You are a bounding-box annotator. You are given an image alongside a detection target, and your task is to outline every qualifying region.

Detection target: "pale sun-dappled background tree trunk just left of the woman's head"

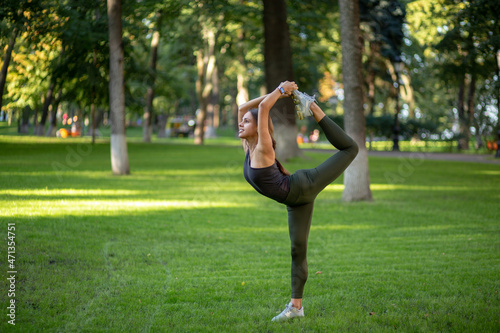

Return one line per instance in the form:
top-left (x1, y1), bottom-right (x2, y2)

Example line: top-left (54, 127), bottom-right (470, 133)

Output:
top-left (194, 23), bottom-right (215, 145)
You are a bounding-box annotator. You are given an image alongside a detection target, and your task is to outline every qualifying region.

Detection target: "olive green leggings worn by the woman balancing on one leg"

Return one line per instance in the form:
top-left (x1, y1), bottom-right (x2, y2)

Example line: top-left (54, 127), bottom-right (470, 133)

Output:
top-left (284, 117), bottom-right (358, 298)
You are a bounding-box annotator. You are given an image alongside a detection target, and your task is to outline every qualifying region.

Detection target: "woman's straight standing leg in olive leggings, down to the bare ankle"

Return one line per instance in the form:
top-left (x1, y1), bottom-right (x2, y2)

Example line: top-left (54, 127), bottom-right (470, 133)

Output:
top-left (287, 202), bottom-right (314, 308)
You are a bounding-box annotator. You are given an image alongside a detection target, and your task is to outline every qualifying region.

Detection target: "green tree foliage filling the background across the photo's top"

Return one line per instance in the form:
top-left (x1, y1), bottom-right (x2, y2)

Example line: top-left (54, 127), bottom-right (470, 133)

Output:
top-left (0, 0), bottom-right (500, 149)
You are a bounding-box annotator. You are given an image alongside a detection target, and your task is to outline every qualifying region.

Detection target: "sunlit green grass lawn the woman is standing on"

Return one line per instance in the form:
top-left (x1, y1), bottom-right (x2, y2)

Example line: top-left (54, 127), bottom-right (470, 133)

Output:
top-left (0, 136), bottom-right (500, 332)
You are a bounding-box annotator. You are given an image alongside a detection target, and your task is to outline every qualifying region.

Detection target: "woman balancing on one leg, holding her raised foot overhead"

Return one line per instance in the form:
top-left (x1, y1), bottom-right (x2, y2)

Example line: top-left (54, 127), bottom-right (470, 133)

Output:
top-left (238, 81), bottom-right (358, 321)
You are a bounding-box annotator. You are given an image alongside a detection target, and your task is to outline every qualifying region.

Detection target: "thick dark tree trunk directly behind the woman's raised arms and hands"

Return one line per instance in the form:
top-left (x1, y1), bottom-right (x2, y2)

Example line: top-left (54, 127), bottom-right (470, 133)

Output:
top-left (263, 0), bottom-right (300, 161)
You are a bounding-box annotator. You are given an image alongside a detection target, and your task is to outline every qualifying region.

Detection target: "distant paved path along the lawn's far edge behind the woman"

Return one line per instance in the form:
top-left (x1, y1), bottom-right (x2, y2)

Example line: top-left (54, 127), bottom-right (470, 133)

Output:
top-left (304, 149), bottom-right (500, 165)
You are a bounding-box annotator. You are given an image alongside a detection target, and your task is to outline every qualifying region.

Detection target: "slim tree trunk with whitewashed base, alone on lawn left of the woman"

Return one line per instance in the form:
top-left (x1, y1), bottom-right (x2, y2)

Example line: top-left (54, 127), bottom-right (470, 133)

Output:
top-left (108, 0), bottom-right (130, 175)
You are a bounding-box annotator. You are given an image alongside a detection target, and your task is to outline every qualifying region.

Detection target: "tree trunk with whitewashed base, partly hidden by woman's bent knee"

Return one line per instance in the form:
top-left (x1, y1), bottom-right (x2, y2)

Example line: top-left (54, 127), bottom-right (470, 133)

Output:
top-left (339, 0), bottom-right (372, 201)
